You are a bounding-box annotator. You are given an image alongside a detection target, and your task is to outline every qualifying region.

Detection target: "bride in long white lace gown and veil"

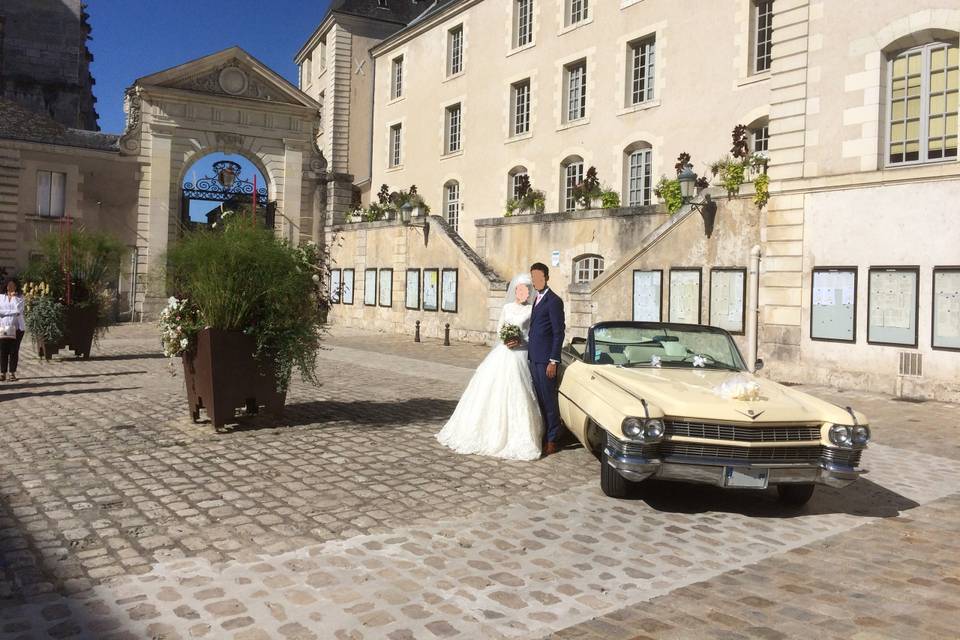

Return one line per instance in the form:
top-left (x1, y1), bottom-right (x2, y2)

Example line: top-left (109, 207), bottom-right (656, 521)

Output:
top-left (437, 274), bottom-right (543, 460)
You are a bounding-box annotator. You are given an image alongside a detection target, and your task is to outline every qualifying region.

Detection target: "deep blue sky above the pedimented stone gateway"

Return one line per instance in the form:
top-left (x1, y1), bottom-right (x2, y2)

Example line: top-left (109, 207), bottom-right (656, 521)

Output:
top-left (87, 0), bottom-right (330, 133)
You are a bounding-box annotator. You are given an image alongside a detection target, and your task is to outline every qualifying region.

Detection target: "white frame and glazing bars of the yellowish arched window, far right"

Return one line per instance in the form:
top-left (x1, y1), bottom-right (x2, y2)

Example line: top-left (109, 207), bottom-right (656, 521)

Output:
top-left (883, 41), bottom-right (960, 167)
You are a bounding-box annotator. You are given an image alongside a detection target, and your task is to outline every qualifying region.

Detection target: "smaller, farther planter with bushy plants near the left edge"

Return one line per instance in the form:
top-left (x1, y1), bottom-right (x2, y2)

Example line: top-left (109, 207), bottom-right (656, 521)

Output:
top-left (23, 229), bottom-right (126, 360)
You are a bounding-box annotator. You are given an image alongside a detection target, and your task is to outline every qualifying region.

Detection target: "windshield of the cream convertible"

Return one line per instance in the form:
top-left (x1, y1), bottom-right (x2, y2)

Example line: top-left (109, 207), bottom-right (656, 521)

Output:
top-left (588, 324), bottom-right (746, 371)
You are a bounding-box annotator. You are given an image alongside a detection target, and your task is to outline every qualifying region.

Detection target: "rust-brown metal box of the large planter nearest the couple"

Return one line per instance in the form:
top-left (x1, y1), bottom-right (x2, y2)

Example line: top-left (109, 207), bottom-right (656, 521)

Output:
top-left (183, 329), bottom-right (287, 429)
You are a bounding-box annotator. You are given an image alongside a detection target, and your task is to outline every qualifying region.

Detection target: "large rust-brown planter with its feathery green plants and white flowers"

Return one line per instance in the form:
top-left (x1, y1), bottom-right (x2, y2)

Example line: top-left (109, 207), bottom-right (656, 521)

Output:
top-left (160, 220), bottom-right (329, 429)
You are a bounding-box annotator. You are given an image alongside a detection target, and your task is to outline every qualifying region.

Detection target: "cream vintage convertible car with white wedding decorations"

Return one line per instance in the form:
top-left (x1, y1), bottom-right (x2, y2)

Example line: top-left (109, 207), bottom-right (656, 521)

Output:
top-left (560, 322), bottom-right (870, 505)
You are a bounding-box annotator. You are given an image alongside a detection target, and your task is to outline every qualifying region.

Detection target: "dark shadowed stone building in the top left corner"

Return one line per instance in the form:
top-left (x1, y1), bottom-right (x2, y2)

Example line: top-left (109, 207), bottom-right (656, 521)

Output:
top-left (0, 0), bottom-right (99, 131)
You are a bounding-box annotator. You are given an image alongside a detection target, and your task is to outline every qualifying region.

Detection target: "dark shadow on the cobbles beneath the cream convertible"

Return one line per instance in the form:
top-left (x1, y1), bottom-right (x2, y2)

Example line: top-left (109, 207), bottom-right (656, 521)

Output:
top-left (631, 478), bottom-right (920, 518)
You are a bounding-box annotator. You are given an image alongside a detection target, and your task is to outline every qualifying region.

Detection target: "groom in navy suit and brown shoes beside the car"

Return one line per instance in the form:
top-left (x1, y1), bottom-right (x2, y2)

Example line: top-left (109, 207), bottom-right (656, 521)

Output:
top-left (527, 262), bottom-right (566, 456)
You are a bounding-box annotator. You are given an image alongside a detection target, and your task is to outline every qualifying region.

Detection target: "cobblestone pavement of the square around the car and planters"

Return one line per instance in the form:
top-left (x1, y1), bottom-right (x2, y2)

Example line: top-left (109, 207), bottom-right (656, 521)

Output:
top-left (0, 326), bottom-right (960, 640)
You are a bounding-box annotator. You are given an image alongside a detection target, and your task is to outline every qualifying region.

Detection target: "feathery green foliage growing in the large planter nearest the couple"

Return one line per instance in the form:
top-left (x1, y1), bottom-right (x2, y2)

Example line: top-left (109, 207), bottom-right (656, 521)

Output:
top-left (168, 223), bottom-right (329, 389)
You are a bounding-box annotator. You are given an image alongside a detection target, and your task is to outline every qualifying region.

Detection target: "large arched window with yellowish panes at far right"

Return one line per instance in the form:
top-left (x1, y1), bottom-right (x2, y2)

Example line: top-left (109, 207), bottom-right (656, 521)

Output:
top-left (887, 42), bottom-right (960, 164)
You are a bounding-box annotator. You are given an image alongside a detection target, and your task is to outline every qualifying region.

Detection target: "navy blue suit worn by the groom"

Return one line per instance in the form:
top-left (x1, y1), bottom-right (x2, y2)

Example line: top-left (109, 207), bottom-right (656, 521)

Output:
top-left (527, 288), bottom-right (566, 442)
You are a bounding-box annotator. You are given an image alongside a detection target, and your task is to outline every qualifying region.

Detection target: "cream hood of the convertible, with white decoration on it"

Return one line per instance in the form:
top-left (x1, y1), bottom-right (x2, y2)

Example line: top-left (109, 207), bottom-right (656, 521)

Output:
top-left (593, 365), bottom-right (866, 424)
